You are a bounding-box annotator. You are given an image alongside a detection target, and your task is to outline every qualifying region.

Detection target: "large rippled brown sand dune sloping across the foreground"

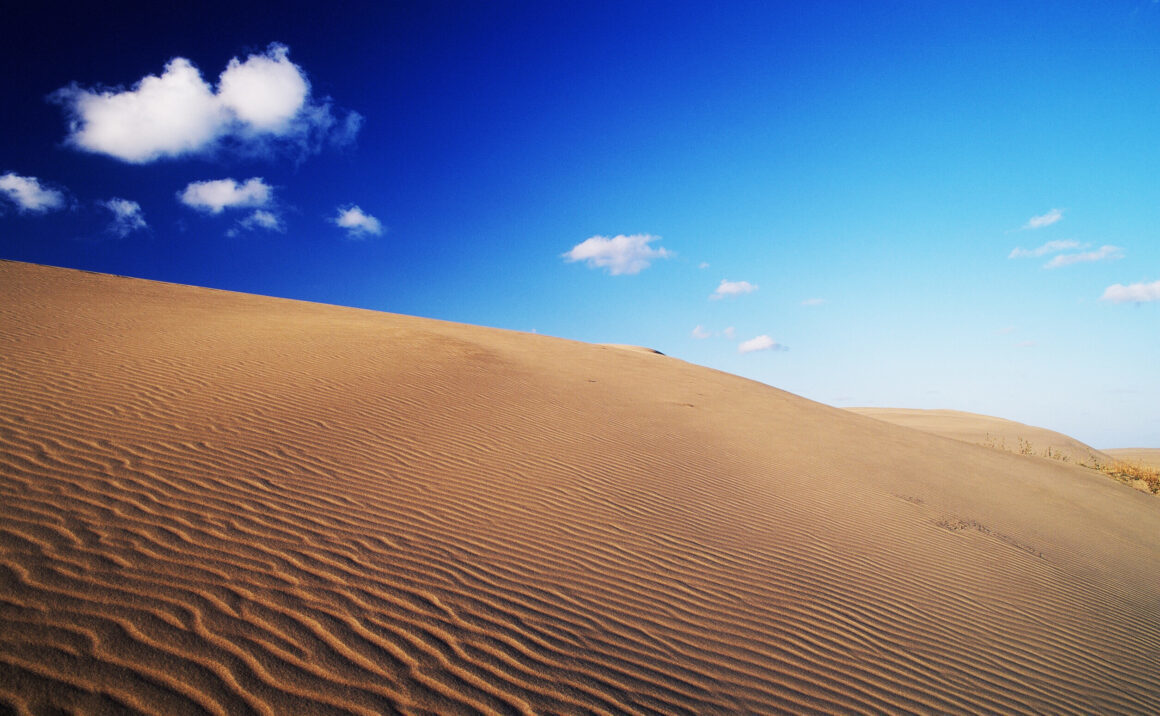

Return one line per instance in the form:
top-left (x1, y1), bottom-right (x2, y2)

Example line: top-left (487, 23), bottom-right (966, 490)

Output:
top-left (0, 262), bottom-right (1160, 714)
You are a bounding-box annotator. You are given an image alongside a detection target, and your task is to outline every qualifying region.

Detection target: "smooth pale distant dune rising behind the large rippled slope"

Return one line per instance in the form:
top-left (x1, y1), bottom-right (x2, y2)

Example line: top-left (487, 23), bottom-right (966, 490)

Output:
top-left (848, 407), bottom-right (1111, 464)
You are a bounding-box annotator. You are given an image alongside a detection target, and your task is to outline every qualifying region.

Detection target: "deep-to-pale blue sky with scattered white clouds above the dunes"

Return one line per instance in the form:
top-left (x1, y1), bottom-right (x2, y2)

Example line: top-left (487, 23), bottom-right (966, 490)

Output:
top-left (0, 0), bottom-right (1160, 447)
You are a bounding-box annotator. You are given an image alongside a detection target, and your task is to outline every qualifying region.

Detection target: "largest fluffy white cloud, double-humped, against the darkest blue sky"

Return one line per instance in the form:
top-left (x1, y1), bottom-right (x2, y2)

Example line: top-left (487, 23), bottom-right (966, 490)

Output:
top-left (52, 44), bottom-right (362, 164)
